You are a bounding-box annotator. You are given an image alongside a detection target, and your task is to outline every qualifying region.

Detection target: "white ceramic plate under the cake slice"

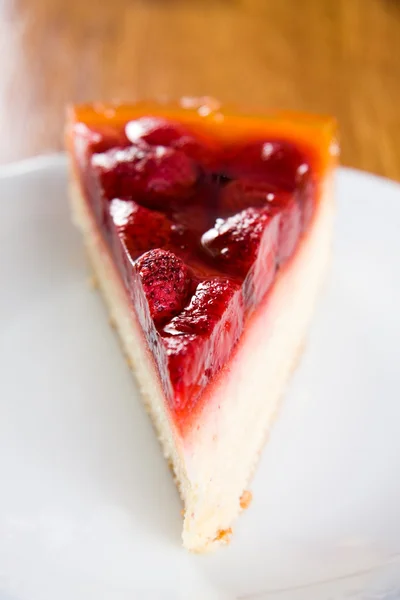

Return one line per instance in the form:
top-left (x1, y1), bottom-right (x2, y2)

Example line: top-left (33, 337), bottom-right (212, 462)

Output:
top-left (0, 156), bottom-right (400, 600)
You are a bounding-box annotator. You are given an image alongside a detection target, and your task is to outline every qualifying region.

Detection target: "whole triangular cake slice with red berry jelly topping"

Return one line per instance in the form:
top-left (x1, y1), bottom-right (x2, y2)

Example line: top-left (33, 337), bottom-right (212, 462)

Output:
top-left (67, 98), bottom-right (337, 552)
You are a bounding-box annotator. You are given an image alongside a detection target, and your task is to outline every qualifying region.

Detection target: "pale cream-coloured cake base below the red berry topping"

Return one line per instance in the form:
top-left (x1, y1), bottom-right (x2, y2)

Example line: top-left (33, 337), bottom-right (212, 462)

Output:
top-left (71, 171), bottom-right (334, 552)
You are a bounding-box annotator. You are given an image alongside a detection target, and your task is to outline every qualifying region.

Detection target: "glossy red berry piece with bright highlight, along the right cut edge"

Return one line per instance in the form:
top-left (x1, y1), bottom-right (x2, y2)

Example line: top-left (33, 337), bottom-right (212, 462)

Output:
top-left (201, 207), bottom-right (279, 278)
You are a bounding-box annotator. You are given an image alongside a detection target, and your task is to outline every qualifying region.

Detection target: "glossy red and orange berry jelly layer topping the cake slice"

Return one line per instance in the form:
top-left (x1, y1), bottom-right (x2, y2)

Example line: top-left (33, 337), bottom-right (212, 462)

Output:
top-left (72, 103), bottom-right (334, 427)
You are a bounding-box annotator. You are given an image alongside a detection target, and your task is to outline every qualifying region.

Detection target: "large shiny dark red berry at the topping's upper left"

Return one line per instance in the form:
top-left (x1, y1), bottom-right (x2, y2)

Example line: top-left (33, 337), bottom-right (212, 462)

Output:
top-left (92, 145), bottom-right (198, 208)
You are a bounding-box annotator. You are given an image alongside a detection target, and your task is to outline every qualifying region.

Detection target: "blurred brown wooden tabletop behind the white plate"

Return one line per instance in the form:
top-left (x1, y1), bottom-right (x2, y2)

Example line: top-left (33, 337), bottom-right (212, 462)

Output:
top-left (0, 0), bottom-right (400, 179)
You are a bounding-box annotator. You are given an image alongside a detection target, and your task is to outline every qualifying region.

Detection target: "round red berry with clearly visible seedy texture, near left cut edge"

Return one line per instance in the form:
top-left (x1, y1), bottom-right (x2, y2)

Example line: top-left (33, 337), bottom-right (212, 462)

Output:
top-left (136, 248), bottom-right (191, 326)
